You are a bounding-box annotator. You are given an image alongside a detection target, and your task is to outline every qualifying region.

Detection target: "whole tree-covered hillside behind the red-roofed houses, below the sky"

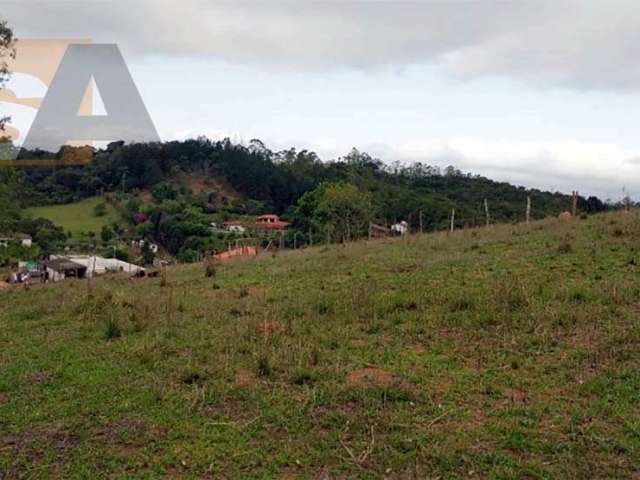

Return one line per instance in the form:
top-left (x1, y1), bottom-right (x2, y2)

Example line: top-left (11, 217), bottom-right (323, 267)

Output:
top-left (0, 138), bottom-right (606, 264)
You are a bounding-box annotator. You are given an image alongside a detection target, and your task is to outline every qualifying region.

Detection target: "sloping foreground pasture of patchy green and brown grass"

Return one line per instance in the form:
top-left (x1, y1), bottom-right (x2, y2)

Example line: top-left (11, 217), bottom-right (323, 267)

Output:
top-left (0, 213), bottom-right (640, 479)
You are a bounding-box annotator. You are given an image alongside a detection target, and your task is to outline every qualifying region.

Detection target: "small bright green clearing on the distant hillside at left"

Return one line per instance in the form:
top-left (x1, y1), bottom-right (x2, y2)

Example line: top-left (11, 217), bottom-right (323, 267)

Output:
top-left (27, 197), bottom-right (118, 238)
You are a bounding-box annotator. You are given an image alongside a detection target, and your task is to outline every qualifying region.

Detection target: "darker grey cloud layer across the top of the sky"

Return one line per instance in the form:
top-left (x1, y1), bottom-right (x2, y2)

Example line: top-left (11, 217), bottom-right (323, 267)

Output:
top-left (0, 0), bottom-right (640, 90)
